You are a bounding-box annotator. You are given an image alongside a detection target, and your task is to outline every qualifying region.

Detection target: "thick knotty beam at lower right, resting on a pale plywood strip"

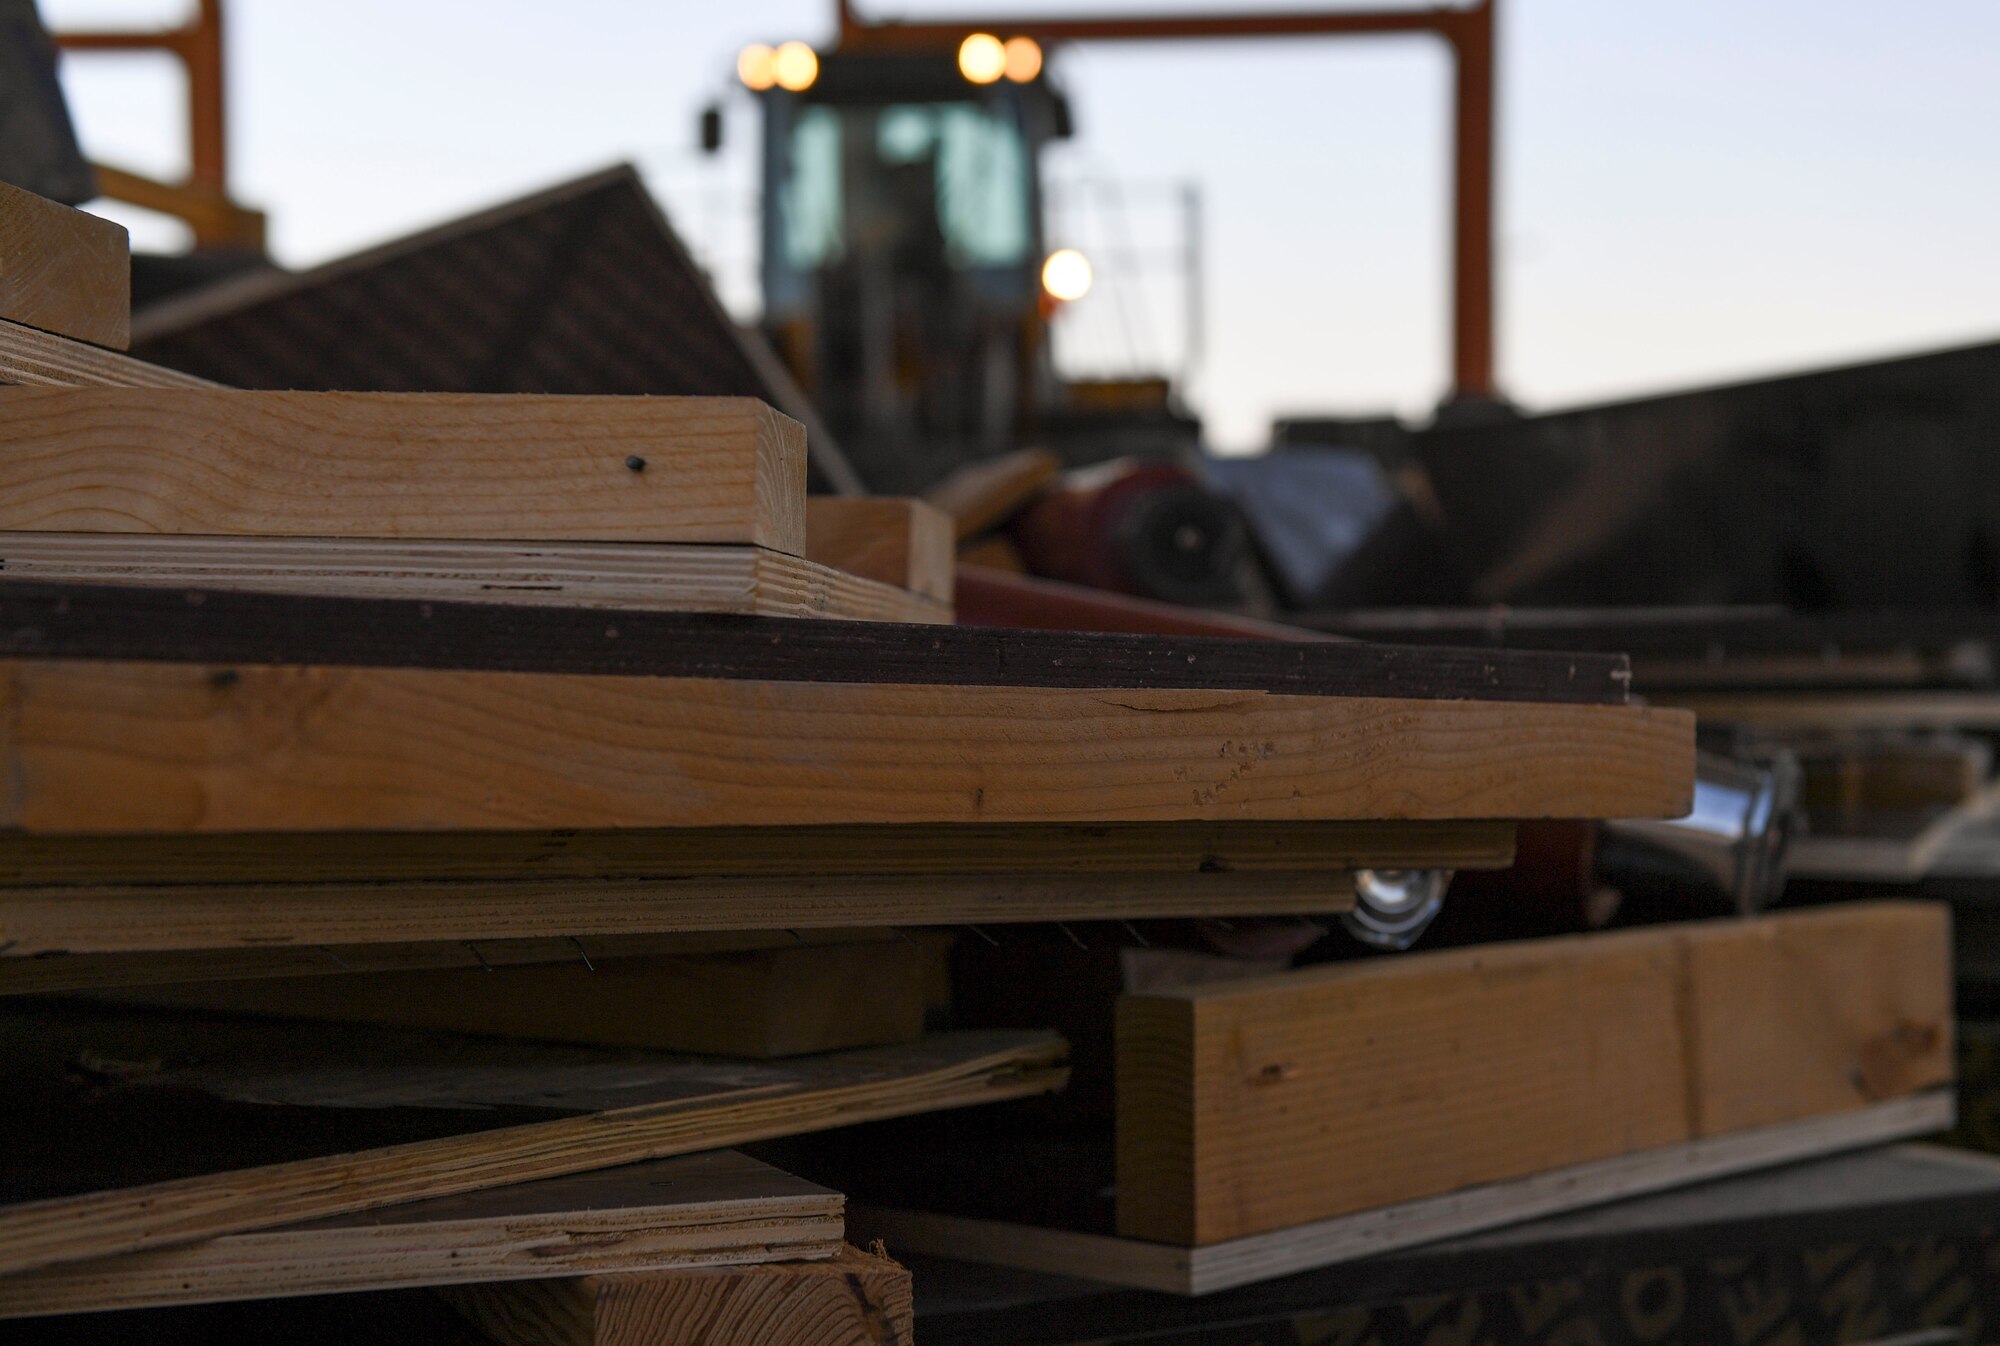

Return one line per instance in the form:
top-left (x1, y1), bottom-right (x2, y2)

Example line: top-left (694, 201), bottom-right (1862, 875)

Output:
top-left (1118, 904), bottom-right (1952, 1244)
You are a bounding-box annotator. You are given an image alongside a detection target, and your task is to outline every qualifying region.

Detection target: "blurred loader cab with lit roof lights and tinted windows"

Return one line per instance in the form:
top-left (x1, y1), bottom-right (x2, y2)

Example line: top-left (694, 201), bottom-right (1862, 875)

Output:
top-left (746, 50), bottom-right (1068, 490)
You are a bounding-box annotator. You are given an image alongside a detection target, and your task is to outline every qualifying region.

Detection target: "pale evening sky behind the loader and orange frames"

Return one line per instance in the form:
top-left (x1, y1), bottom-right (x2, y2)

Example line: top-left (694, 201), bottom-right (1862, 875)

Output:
top-left (42, 0), bottom-right (2000, 448)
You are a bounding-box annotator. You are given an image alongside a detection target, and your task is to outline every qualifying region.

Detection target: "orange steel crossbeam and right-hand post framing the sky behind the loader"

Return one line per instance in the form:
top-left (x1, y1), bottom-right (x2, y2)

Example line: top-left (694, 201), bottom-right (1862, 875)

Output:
top-left (834, 0), bottom-right (1498, 398)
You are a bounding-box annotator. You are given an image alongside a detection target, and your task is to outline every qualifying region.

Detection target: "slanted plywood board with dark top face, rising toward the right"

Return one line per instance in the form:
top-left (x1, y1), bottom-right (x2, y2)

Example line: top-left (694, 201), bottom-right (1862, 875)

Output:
top-left (0, 1002), bottom-right (1066, 1272)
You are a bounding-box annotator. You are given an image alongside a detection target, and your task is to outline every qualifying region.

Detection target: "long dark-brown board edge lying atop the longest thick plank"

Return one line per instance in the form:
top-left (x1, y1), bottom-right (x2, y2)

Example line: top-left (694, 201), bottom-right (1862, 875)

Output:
top-left (0, 580), bottom-right (1630, 706)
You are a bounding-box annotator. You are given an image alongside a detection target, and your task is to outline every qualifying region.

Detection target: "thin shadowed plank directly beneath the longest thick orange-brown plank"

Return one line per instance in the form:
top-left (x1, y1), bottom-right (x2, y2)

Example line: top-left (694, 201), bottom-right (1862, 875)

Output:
top-left (0, 820), bottom-right (1514, 888)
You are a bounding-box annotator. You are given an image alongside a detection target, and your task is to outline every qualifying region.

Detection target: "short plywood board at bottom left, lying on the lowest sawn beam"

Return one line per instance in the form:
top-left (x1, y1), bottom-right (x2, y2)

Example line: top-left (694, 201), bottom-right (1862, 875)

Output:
top-left (0, 1150), bottom-right (842, 1318)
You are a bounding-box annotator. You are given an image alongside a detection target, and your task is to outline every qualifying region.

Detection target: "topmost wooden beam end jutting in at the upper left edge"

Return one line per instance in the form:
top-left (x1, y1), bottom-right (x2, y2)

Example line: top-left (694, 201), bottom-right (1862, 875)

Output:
top-left (0, 182), bottom-right (132, 350)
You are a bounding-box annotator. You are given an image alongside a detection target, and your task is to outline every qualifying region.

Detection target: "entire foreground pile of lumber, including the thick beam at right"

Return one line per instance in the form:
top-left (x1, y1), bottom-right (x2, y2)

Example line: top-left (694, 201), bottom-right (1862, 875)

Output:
top-left (0, 171), bottom-right (1948, 1342)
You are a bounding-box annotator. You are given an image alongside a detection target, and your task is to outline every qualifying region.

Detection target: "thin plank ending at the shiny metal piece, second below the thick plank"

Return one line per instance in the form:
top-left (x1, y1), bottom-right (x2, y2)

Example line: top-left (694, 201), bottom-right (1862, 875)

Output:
top-left (0, 868), bottom-right (1360, 972)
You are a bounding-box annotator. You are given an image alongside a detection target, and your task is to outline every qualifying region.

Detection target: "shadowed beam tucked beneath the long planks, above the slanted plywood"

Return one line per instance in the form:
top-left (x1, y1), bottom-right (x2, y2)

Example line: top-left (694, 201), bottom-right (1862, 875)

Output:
top-left (106, 938), bottom-right (950, 1058)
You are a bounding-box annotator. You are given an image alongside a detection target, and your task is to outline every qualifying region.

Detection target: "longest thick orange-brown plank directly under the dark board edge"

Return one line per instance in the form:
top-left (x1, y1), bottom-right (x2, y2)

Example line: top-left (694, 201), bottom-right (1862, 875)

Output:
top-left (0, 660), bottom-right (1694, 832)
